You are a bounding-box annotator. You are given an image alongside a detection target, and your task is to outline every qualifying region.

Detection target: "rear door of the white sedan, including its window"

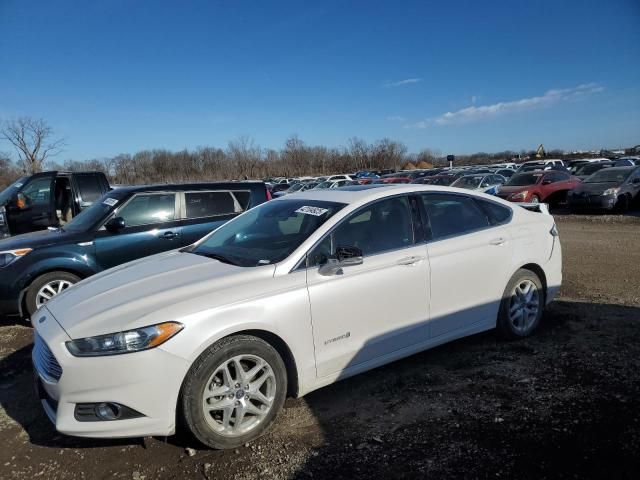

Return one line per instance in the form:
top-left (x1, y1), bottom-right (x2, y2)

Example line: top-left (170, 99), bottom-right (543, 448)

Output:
top-left (421, 193), bottom-right (513, 338)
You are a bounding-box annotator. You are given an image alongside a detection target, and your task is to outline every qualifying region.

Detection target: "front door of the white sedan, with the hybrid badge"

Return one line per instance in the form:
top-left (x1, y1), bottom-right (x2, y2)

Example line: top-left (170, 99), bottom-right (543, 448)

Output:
top-left (307, 196), bottom-right (429, 377)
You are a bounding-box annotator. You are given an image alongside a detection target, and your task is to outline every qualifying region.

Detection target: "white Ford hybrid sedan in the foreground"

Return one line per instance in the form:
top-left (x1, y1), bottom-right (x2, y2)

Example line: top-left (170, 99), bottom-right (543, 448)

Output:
top-left (32, 185), bottom-right (561, 448)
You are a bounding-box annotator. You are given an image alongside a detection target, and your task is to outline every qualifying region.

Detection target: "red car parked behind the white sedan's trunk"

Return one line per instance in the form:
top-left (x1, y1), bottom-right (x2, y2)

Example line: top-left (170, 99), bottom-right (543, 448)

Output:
top-left (498, 170), bottom-right (580, 204)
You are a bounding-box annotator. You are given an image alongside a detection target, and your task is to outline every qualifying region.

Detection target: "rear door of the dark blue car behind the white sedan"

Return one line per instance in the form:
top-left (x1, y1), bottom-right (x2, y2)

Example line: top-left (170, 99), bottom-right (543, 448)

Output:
top-left (180, 190), bottom-right (251, 245)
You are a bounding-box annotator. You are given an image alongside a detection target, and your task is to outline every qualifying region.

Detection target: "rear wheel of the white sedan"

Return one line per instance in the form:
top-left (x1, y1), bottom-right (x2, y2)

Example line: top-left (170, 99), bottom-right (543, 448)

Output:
top-left (497, 269), bottom-right (545, 339)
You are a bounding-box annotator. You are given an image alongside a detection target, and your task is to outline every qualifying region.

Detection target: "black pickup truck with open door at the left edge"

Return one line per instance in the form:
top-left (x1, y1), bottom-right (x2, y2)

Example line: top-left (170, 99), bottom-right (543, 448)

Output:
top-left (0, 171), bottom-right (111, 238)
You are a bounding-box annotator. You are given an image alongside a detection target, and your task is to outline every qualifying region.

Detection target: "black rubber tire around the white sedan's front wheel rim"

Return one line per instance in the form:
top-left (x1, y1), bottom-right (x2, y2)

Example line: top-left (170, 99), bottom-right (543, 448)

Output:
top-left (178, 335), bottom-right (287, 450)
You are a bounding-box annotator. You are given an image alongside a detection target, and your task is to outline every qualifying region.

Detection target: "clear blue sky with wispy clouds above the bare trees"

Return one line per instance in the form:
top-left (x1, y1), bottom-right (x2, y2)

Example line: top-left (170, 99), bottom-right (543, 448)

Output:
top-left (0, 0), bottom-right (640, 159)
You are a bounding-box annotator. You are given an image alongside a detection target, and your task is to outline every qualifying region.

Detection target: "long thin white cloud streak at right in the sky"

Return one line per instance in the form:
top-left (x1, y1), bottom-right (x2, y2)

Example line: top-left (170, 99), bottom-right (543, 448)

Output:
top-left (405, 83), bottom-right (604, 128)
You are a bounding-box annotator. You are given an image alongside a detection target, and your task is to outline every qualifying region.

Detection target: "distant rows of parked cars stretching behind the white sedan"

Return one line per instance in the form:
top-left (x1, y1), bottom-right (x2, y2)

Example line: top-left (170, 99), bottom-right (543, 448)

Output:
top-left (271, 157), bottom-right (640, 211)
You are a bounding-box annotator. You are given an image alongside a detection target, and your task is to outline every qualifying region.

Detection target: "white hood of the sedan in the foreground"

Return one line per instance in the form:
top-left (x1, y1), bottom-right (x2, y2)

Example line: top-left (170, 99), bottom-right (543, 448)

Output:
top-left (45, 250), bottom-right (275, 338)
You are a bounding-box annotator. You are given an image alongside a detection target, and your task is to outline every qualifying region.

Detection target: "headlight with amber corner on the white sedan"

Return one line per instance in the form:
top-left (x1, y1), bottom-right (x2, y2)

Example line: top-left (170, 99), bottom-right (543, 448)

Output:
top-left (67, 322), bottom-right (184, 357)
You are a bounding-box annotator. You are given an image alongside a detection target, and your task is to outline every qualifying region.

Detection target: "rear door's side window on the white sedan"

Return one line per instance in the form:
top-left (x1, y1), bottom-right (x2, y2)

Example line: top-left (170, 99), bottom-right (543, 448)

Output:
top-left (421, 193), bottom-right (490, 240)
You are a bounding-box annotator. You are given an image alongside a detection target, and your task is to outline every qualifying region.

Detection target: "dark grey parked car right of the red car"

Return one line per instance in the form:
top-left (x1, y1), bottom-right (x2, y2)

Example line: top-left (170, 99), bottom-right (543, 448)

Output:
top-left (567, 167), bottom-right (640, 211)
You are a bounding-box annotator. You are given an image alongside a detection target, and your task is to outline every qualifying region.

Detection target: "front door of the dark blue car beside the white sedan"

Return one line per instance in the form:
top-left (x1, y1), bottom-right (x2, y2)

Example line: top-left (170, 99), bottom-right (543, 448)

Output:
top-left (95, 192), bottom-right (182, 269)
